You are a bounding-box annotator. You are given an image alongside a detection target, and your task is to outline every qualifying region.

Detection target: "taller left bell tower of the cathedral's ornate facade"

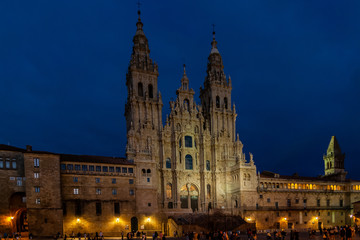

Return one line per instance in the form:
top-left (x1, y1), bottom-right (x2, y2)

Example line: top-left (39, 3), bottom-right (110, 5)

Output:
top-left (125, 10), bottom-right (163, 214)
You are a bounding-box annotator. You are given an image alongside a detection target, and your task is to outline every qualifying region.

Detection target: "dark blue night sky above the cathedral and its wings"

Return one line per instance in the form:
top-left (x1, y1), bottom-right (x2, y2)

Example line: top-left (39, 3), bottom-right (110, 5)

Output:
top-left (0, 0), bottom-right (360, 179)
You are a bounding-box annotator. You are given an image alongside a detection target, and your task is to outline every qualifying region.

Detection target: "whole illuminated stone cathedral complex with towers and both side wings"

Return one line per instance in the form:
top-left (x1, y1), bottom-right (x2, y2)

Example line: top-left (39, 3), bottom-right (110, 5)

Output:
top-left (0, 9), bottom-right (360, 236)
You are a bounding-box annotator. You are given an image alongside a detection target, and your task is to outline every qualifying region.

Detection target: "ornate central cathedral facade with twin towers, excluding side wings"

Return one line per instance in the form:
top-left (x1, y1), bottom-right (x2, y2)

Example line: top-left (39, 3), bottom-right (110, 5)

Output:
top-left (125, 12), bottom-right (248, 214)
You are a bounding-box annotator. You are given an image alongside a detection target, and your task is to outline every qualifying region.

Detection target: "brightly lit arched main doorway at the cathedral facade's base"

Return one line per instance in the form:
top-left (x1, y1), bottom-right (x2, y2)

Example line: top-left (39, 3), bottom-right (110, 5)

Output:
top-left (180, 183), bottom-right (199, 212)
